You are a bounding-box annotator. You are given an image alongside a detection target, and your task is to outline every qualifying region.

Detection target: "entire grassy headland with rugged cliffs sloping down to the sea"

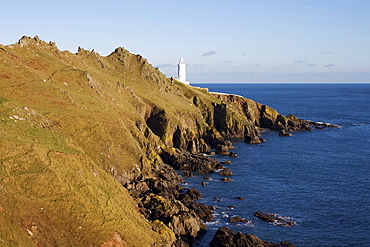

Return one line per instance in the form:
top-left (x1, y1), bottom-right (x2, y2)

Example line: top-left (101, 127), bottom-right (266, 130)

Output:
top-left (0, 36), bottom-right (309, 246)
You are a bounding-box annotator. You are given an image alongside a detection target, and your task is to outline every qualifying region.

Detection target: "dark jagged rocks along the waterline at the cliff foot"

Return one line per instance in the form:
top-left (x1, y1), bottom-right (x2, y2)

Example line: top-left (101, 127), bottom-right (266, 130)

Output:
top-left (126, 120), bottom-right (336, 247)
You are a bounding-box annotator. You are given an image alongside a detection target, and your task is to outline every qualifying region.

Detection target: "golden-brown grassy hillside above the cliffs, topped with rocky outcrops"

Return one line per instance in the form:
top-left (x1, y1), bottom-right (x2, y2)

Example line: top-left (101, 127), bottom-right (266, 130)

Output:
top-left (0, 37), bottom-right (212, 246)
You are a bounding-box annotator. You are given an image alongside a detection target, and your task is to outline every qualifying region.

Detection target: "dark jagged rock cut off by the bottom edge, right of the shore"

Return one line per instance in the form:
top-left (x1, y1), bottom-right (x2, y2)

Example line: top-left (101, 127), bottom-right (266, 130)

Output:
top-left (210, 227), bottom-right (294, 247)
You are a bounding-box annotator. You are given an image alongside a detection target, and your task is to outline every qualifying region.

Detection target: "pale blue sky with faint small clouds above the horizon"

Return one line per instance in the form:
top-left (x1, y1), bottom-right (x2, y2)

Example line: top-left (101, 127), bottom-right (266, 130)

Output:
top-left (0, 0), bottom-right (370, 83)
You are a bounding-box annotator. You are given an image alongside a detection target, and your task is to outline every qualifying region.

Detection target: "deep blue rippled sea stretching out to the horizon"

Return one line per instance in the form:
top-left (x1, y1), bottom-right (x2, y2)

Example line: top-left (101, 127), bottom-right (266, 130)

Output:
top-left (184, 83), bottom-right (370, 247)
